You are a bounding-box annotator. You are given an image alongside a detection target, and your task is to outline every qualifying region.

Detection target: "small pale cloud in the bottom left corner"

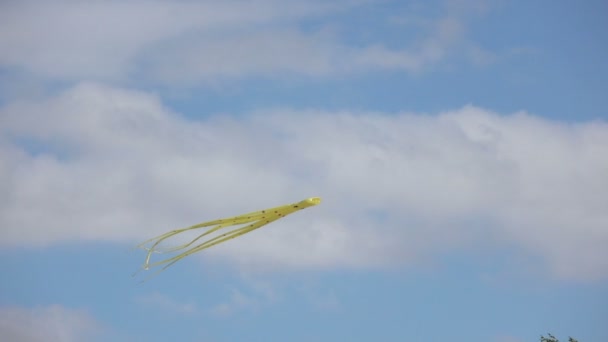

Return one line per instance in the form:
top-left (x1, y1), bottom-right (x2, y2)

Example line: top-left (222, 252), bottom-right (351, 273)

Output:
top-left (0, 305), bottom-right (100, 342)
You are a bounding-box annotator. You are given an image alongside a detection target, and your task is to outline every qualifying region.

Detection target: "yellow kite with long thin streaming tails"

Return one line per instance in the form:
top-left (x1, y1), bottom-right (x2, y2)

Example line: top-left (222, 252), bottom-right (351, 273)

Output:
top-left (137, 197), bottom-right (321, 272)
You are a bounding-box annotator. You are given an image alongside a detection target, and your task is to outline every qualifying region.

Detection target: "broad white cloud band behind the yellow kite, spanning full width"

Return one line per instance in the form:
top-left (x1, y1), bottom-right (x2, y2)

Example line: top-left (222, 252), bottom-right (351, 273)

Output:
top-left (0, 84), bottom-right (608, 279)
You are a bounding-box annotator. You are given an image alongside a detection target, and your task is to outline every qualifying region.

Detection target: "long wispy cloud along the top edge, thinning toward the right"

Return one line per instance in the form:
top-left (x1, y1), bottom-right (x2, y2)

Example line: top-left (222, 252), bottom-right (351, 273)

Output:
top-left (0, 0), bottom-right (488, 84)
